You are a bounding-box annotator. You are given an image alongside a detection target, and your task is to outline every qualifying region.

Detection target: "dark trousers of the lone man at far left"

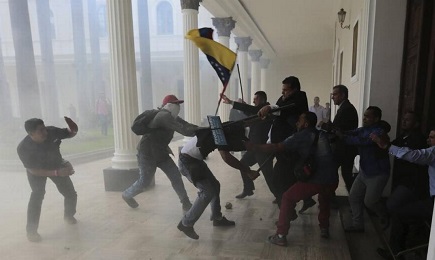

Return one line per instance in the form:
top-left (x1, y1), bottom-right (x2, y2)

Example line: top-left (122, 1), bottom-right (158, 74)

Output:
top-left (26, 172), bottom-right (77, 232)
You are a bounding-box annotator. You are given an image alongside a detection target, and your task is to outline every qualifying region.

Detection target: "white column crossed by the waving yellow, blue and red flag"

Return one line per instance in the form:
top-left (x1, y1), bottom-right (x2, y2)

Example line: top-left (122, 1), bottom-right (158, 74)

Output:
top-left (211, 17), bottom-right (237, 122)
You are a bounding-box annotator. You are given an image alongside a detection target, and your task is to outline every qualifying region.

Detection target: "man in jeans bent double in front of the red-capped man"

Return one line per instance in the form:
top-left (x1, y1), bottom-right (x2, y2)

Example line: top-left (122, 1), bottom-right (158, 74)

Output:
top-left (177, 126), bottom-right (259, 239)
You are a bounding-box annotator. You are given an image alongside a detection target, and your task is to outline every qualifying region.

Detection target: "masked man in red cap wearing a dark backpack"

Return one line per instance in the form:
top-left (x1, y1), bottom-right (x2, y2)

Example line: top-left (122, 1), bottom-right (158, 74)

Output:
top-left (122, 95), bottom-right (198, 211)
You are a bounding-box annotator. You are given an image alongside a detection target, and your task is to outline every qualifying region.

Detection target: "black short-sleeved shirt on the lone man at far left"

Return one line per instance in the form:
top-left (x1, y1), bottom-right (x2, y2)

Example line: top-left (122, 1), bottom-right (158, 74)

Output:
top-left (17, 126), bottom-right (69, 170)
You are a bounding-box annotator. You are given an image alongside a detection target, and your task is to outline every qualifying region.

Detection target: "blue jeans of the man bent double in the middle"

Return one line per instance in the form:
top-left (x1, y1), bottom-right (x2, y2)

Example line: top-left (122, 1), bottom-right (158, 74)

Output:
top-left (178, 154), bottom-right (222, 227)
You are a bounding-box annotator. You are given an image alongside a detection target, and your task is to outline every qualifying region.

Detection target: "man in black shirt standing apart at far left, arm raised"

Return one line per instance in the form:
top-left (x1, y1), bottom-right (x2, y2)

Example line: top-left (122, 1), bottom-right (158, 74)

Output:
top-left (17, 117), bottom-right (78, 242)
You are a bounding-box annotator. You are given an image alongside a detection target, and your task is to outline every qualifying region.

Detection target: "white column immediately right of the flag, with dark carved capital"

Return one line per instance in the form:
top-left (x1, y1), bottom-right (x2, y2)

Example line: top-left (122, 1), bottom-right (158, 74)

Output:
top-left (235, 37), bottom-right (252, 103)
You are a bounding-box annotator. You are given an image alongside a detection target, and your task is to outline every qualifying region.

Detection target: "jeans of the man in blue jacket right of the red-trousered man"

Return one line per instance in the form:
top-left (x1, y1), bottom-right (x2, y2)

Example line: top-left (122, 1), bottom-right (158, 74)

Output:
top-left (349, 171), bottom-right (389, 227)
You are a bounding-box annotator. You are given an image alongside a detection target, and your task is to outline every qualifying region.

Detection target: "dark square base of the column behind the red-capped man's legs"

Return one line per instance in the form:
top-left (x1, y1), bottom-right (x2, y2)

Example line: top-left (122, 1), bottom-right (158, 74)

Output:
top-left (103, 168), bottom-right (156, 191)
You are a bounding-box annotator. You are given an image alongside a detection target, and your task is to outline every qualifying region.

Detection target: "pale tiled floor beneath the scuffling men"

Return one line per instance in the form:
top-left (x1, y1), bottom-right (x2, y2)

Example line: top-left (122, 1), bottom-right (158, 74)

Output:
top-left (0, 141), bottom-right (350, 260)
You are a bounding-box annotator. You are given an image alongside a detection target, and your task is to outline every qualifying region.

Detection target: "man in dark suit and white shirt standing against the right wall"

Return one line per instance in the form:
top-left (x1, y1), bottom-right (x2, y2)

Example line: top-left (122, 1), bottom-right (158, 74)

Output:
top-left (322, 85), bottom-right (358, 191)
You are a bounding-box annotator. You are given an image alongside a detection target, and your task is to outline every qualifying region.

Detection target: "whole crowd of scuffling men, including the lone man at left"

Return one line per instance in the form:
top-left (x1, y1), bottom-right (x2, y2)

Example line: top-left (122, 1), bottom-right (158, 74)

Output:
top-left (17, 76), bottom-right (435, 258)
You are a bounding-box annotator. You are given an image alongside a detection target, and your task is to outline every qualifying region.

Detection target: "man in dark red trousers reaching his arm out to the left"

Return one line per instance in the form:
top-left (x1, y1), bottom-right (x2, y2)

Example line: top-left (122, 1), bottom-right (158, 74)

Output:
top-left (246, 112), bottom-right (338, 246)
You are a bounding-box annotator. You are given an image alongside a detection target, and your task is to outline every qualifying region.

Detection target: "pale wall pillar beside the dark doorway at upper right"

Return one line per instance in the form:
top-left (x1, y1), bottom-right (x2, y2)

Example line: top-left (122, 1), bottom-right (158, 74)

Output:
top-left (369, 0), bottom-right (406, 138)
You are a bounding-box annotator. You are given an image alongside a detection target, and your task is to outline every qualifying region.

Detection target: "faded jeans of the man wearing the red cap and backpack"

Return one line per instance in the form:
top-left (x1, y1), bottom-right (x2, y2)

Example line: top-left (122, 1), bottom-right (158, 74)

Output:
top-left (123, 152), bottom-right (189, 203)
